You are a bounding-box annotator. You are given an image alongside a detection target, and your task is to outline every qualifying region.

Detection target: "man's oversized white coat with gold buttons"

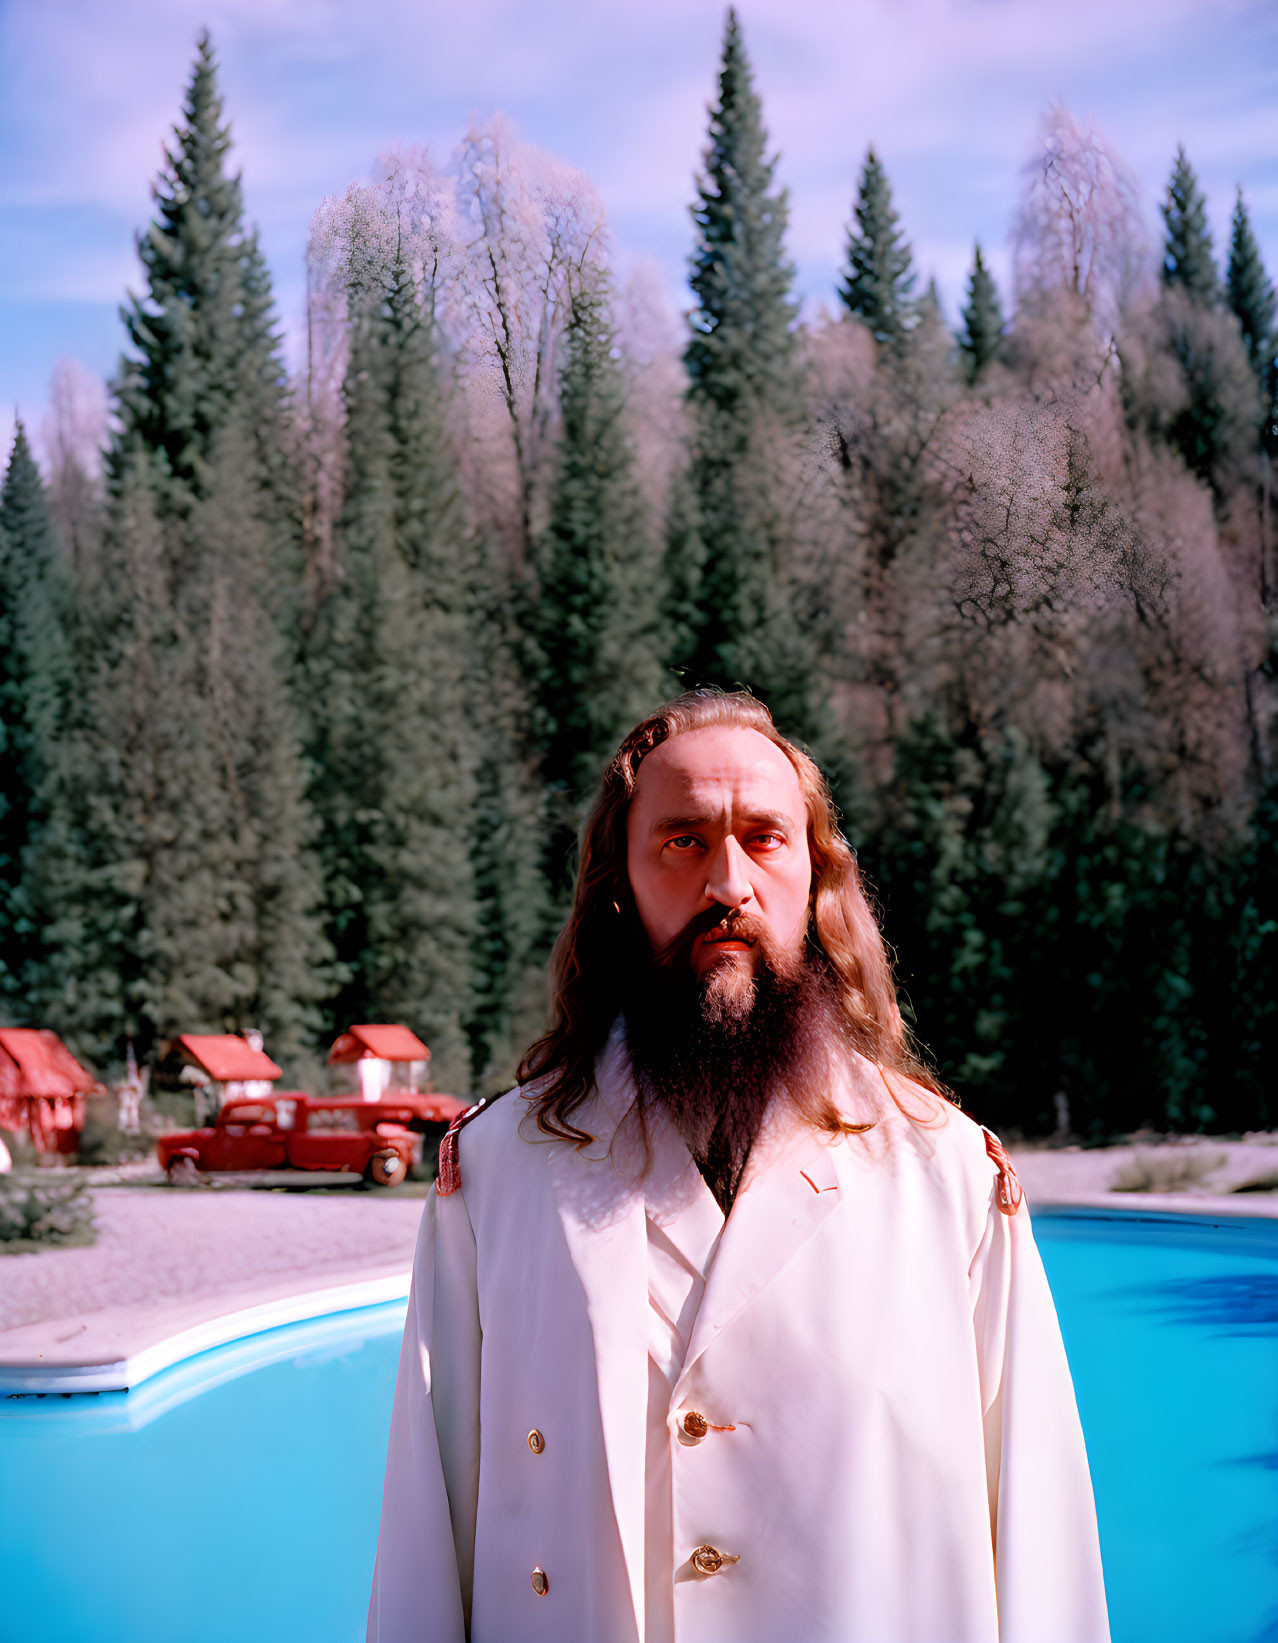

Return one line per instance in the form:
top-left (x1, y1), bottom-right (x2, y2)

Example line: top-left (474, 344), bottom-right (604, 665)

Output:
top-left (368, 1033), bottom-right (1109, 1643)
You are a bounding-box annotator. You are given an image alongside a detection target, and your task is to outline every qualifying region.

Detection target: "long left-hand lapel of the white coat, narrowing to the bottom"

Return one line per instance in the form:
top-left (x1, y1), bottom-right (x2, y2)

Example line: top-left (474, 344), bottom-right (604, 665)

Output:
top-left (549, 1043), bottom-right (649, 1638)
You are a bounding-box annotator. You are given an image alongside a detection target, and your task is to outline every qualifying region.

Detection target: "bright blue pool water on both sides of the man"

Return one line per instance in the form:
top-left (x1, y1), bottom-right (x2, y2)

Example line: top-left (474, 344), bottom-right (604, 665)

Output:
top-left (0, 1211), bottom-right (1278, 1643)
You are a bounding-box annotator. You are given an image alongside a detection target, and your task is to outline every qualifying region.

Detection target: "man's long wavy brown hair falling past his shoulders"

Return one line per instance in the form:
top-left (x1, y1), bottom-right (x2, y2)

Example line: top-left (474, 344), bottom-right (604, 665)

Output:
top-left (519, 690), bottom-right (953, 1145)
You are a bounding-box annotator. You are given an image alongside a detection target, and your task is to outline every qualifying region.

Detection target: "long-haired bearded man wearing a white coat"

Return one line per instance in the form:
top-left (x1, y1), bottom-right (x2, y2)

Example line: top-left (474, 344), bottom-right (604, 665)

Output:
top-left (368, 692), bottom-right (1109, 1643)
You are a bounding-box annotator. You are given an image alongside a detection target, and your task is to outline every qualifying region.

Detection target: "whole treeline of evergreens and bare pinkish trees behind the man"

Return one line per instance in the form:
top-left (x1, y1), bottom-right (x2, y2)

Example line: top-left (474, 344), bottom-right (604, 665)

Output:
top-left (0, 12), bottom-right (1278, 1135)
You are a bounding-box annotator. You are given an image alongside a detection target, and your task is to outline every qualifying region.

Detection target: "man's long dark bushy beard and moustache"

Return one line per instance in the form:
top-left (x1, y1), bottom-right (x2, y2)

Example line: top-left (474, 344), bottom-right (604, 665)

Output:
top-left (623, 907), bottom-right (841, 1213)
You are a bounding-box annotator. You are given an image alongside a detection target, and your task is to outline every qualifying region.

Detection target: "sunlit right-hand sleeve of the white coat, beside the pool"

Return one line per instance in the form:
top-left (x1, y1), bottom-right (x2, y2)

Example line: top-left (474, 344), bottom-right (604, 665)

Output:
top-left (971, 1203), bottom-right (1109, 1643)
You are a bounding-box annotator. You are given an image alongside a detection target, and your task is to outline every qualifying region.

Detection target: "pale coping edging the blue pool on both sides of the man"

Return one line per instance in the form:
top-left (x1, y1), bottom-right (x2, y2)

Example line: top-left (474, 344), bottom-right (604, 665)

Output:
top-left (0, 1191), bottom-right (1278, 1397)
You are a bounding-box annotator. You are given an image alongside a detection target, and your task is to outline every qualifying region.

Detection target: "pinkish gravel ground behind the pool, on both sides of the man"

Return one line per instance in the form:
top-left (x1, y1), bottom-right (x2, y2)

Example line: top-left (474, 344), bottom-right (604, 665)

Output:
top-left (0, 1134), bottom-right (1278, 1331)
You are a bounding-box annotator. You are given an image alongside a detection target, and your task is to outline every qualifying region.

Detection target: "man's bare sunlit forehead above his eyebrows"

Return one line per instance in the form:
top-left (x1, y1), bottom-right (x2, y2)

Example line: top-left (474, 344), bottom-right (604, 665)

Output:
top-left (634, 726), bottom-right (807, 818)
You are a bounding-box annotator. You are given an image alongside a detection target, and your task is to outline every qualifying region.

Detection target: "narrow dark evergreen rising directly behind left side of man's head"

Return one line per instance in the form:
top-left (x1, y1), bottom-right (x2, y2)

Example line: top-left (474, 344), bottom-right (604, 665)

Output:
top-left (527, 278), bottom-right (669, 922)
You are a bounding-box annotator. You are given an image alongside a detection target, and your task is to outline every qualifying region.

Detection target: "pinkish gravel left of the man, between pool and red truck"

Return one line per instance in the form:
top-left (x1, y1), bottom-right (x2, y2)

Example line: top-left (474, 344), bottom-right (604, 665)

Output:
top-left (0, 1186), bottom-right (422, 1329)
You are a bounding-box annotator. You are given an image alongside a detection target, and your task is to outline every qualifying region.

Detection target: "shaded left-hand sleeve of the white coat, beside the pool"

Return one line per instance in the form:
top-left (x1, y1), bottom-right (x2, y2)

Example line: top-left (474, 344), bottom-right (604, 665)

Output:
top-left (368, 1193), bottom-right (480, 1643)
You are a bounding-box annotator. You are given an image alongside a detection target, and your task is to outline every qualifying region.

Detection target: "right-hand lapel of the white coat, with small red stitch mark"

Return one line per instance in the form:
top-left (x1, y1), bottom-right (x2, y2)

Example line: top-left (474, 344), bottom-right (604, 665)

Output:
top-left (673, 1125), bottom-right (846, 1403)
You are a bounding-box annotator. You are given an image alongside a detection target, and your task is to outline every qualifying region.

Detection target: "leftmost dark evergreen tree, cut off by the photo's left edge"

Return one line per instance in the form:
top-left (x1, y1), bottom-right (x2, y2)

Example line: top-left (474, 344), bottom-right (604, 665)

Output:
top-left (0, 421), bottom-right (72, 1020)
